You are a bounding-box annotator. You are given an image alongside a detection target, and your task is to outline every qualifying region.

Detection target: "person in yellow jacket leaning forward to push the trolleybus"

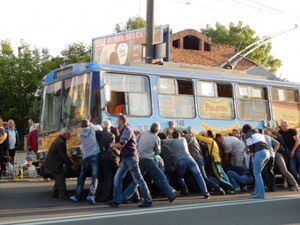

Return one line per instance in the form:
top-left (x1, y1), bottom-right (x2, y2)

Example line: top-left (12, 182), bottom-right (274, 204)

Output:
top-left (188, 127), bottom-right (235, 194)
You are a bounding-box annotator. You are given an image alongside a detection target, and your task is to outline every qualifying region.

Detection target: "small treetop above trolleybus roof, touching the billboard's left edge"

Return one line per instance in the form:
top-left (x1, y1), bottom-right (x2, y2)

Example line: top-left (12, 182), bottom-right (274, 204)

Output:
top-left (61, 42), bottom-right (91, 64)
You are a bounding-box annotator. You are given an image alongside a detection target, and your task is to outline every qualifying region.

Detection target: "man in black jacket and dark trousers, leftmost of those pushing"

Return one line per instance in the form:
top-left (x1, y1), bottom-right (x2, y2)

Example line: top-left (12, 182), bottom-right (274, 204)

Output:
top-left (43, 128), bottom-right (76, 200)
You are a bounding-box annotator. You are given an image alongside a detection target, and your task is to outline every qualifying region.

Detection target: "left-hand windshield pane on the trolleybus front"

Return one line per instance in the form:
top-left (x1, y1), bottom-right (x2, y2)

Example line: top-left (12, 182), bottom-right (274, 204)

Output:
top-left (40, 81), bottom-right (62, 131)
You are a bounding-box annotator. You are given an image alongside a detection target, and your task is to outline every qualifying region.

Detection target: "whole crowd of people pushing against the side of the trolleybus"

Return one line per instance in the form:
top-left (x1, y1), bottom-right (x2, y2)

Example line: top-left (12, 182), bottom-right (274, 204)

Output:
top-left (44, 115), bottom-right (300, 207)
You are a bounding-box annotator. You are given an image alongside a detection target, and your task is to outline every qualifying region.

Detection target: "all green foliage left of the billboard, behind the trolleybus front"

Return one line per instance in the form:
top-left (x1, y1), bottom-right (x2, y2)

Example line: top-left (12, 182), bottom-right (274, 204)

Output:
top-left (0, 41), bottom-right (91, 146)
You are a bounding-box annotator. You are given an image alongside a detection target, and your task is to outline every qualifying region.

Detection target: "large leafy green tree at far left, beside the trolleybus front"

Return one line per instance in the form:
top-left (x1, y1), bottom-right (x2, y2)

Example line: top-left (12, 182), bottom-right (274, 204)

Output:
top-left (0, 41), bottom-right (43, 139)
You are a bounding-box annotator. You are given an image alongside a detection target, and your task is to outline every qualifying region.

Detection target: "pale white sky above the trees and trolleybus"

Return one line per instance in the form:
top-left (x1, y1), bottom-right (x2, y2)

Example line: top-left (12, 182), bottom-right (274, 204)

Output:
top-left (0, 0), bottom-right (300, 82)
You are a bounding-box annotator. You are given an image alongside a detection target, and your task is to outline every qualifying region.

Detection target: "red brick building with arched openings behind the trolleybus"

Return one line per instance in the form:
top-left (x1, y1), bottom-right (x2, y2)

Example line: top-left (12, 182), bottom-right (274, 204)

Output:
top-left (170, 29), bottom-right (257, 70)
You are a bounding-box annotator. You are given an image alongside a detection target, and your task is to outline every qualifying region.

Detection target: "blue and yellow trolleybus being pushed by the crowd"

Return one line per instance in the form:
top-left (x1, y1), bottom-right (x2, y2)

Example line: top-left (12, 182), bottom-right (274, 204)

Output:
top-left (38, 63), bottom-right (300, 178)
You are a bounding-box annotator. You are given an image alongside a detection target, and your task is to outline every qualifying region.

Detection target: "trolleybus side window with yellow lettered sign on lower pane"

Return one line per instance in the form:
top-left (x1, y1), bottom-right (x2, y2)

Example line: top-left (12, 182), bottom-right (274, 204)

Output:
top-left (197, 81), bottom-right (235, 119)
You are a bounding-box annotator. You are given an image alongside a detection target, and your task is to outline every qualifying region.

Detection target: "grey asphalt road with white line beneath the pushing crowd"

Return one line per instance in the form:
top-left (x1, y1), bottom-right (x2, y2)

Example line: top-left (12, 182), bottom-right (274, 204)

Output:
top-left (0, 180), bottom-right (300, 225)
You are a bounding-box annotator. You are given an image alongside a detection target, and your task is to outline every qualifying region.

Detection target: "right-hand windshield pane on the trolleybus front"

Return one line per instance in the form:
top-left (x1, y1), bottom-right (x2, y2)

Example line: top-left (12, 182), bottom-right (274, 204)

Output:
top-left (63, 74), bottom-right (90, 126)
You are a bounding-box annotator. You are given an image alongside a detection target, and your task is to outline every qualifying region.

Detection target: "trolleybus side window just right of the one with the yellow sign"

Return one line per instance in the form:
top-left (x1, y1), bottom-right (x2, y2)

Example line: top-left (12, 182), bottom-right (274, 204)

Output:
top-left (237, 85), bottom-right (270, 121)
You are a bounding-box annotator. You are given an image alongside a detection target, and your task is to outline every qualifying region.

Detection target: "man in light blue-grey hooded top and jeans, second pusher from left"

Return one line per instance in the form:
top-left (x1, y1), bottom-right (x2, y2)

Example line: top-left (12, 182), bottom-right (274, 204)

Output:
top-left (70, 119), bottom-right (100, 205)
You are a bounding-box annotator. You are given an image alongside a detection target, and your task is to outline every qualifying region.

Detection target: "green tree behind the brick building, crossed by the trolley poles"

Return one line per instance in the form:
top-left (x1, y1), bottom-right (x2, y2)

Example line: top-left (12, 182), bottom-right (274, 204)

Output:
top-left (200, 21), bottom-right (282, 74)
